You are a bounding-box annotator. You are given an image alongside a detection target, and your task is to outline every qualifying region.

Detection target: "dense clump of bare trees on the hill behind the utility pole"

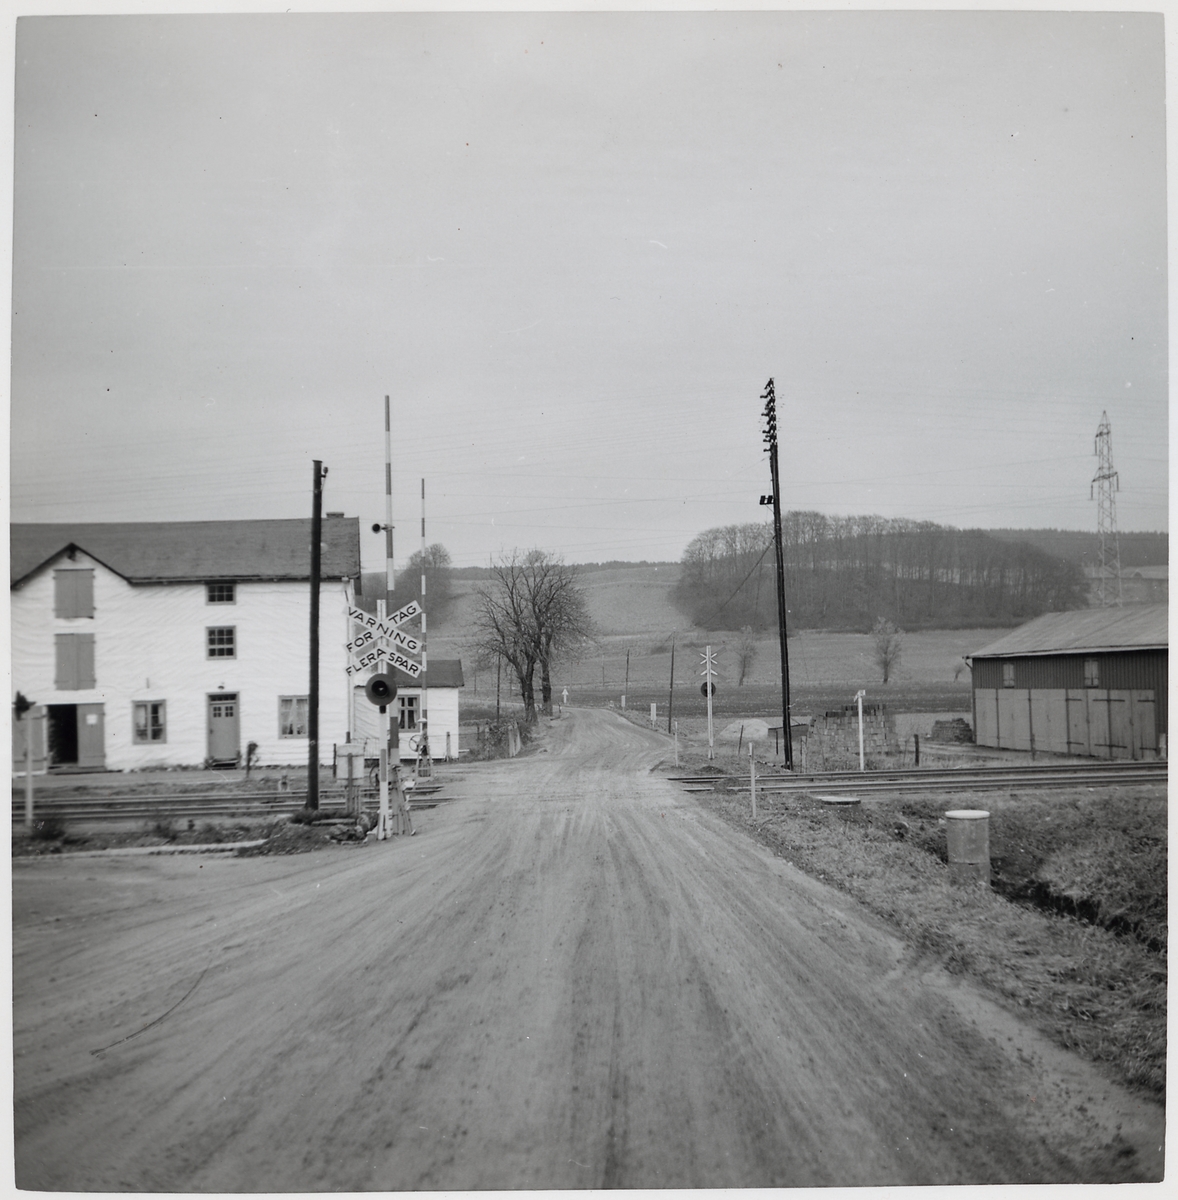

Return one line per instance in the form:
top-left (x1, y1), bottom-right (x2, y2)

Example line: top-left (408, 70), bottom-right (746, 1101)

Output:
top-left (672, 511), bottom-right (1087, 630)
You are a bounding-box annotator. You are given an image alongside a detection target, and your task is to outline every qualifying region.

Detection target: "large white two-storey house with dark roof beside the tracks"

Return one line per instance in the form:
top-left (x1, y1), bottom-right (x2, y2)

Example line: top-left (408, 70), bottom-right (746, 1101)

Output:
top-left (11, 516), bottom-right (360, 770)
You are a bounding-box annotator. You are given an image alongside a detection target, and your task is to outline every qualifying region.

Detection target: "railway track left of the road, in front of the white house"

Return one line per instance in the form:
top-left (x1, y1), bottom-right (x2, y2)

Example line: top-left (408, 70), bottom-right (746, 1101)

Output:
top-left (12, 784), bottom-right (443, 824)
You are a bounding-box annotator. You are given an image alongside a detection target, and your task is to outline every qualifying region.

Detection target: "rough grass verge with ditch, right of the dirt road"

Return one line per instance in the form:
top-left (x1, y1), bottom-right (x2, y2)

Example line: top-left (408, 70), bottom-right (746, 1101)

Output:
top-left (704, 788), bottom-right (1167, 1103)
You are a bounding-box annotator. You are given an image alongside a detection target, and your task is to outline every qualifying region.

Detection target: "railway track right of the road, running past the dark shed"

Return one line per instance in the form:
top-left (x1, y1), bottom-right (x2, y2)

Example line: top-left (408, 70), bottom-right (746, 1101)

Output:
top-left (671, 760), bottom-right (1168, 794)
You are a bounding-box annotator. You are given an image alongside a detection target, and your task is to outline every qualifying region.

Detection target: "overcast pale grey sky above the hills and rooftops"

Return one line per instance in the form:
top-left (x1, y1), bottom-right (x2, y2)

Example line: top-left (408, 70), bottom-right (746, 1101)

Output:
top-left (10, 11), bottom-right (1168, 570)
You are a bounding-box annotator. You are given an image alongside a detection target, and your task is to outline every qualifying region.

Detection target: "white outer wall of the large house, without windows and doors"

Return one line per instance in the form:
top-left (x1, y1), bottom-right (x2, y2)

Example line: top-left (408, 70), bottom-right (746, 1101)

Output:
top-left (11, 553), bottom-right (348, 769)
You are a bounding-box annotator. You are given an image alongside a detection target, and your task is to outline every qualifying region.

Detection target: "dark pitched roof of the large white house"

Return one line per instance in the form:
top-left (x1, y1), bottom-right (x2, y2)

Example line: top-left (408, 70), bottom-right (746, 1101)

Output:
top-left (8, 517), bottom-right (360, 587)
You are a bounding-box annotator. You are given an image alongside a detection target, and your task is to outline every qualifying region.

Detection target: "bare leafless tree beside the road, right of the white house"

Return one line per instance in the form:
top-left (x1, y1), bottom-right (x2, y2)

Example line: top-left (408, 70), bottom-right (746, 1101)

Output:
top-left (475, 550), bottom-right (591, 722)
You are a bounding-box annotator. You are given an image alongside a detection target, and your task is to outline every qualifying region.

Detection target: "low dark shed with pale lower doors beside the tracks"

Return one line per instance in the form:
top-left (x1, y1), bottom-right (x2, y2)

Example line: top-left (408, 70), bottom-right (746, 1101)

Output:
top-left (969, 604), bottom-right (1170, 758)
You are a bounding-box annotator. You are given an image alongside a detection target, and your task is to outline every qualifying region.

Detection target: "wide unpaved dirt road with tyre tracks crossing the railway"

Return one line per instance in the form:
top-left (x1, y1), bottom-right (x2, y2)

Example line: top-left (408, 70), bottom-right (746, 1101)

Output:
top-left (13, 710), bottom-right (1161, 1192)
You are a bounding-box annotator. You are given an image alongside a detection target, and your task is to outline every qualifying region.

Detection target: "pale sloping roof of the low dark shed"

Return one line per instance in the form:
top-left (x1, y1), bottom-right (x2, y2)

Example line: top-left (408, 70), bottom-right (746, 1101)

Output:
top-left (969, 604), bottom-right (1170, 659)
